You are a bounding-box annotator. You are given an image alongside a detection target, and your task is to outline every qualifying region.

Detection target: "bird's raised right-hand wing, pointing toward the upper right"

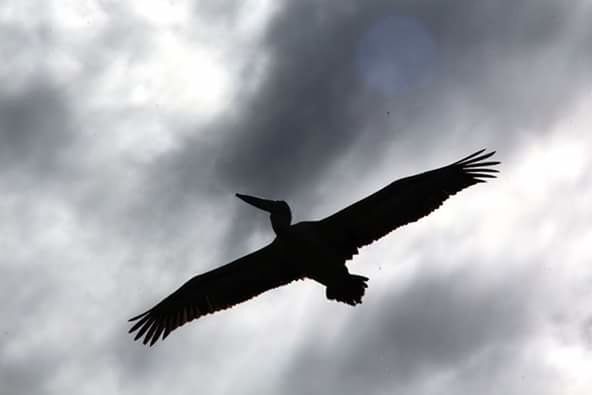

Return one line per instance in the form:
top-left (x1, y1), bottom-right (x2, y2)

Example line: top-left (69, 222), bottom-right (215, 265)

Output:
top-left (320, 150), bottom-right (500, 257)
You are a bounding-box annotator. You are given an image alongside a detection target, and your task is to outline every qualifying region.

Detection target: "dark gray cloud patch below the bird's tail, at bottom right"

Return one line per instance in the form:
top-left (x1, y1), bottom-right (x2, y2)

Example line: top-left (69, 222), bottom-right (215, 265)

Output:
top-left (270, 256), bottom-right (541, 394)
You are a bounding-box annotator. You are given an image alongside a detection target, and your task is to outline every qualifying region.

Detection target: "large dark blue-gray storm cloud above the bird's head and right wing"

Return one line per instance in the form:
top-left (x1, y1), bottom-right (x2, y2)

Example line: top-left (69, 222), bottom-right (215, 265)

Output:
top-left (155, 1), bottom-right (591, 210)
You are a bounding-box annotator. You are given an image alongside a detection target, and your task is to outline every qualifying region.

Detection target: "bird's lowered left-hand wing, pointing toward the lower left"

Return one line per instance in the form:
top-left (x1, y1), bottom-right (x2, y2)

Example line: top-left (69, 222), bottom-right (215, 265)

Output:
top-left (129, 242), bottom-right (303, 346)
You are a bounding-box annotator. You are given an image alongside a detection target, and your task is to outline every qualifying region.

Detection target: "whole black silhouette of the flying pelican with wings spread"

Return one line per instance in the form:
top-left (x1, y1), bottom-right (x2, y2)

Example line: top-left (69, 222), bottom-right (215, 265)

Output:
top-left (129, 150), bottom-right (500, 346)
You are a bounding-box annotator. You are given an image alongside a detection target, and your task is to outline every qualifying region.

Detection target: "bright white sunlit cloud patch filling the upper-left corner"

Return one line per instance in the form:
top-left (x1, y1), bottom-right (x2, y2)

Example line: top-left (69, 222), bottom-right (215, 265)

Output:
top-left (0, 0), bottom-right (276, 160)
